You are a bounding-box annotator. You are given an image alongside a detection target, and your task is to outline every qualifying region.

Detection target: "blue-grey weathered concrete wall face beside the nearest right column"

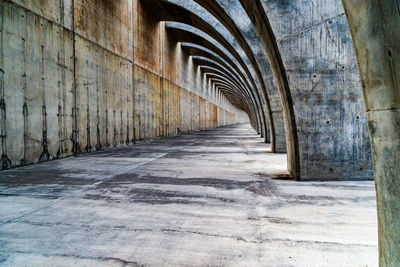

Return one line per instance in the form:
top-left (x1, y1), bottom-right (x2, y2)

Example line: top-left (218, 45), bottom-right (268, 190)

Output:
top-left (262, 0), bottom-right (373, 179)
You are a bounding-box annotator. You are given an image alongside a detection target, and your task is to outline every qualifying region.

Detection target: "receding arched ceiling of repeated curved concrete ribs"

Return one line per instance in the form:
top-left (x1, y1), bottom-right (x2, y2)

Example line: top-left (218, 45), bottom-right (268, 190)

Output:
top-left (138, 0), bottom-right (299, 168)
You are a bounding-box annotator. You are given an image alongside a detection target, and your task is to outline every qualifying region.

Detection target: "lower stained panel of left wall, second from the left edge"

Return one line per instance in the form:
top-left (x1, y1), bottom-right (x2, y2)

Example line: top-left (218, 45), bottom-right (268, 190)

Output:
top-left (75, 36), bottom-right (133, 152)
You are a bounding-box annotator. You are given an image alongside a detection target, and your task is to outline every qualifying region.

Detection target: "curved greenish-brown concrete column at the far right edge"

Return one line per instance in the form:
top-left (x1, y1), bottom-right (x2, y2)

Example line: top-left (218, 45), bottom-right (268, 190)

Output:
top-left (343, 0), bottom-right (400, 266)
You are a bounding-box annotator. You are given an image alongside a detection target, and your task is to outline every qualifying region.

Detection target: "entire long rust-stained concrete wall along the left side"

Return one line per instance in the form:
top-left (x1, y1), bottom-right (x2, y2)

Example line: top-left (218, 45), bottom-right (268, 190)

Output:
top-left (0, 0), bottom-right (243, 169)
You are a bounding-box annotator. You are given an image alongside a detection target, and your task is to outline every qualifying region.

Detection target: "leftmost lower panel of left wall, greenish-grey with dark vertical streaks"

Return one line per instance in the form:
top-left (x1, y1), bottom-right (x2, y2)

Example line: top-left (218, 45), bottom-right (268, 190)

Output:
top-left (1, 2), bottom-right (73, 166)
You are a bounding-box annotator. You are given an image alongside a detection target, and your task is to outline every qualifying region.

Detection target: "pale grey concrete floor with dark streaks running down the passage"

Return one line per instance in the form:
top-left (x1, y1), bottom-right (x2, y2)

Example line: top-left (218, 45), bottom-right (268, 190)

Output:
top-left (0, 124), bottom-right (378, 266)
